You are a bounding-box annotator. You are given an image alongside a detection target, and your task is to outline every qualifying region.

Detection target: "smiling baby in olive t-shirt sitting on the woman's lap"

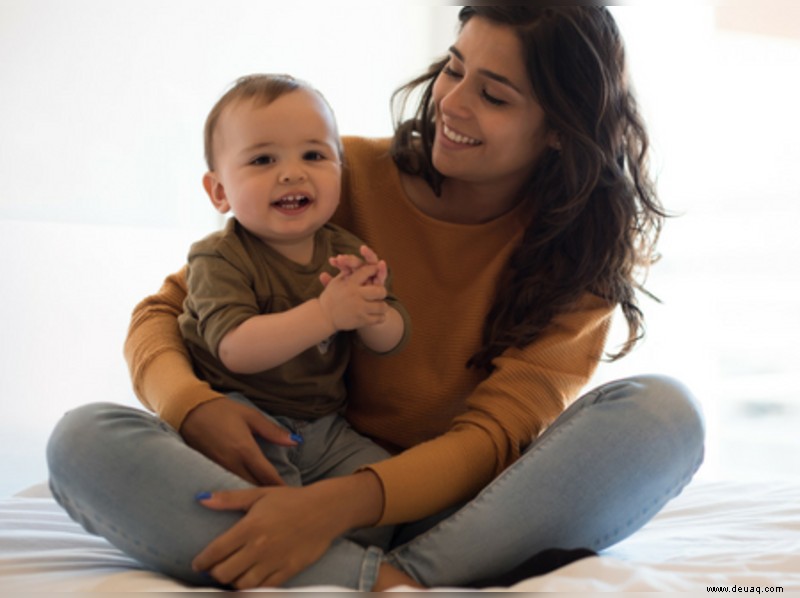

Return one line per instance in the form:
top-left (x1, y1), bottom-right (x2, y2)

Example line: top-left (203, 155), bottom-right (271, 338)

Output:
top-left (179, 75), bottom-right (409, 510)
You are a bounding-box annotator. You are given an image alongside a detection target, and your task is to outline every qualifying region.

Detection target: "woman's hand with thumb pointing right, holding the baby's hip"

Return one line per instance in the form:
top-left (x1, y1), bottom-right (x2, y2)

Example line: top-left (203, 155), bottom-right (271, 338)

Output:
top-left (180, 398), bottom-right (298, 486)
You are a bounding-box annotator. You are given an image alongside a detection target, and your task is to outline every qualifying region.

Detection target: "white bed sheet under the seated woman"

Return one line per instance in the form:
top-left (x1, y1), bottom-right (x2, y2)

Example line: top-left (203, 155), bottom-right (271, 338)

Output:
top-left (0, 480), bottom-right (800, 594)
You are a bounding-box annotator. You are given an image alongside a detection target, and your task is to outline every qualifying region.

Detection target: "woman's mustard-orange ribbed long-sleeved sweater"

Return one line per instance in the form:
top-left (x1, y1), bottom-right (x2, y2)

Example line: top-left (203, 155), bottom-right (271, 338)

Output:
top-left (125, 138), bottom-right (614, 524)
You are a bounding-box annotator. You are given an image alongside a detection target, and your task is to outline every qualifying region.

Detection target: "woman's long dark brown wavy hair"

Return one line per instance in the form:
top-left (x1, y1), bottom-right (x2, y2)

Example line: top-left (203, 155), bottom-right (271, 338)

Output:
top-left (392, 5), bottom-right (666, 371)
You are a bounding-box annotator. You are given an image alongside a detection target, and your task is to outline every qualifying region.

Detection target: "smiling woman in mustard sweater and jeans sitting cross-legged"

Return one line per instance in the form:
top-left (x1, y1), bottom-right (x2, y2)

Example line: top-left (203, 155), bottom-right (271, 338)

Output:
top-left (49, 6), bottom-right (703, 590)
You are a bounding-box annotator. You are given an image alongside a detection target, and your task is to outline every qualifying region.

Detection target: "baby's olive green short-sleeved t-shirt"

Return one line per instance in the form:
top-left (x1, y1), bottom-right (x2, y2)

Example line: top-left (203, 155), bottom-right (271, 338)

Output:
top-left (178, 218), bottom-right (408, 419)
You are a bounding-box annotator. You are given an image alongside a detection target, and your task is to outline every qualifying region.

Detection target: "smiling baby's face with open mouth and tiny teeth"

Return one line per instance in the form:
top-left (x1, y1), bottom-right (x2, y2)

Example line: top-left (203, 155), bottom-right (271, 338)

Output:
top-left (205, 89), bottom-right (341, 254)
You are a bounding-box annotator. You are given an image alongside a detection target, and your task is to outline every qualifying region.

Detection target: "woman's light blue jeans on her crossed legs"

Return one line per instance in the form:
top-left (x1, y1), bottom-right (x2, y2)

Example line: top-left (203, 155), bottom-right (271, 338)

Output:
top-left (47, 376), bottom-right (704, 590)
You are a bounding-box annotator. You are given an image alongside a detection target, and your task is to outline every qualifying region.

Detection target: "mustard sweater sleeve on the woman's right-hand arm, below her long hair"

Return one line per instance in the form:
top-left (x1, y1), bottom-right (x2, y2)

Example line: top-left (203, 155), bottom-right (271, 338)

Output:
top-left (370, 295), bottom-right (613, 525)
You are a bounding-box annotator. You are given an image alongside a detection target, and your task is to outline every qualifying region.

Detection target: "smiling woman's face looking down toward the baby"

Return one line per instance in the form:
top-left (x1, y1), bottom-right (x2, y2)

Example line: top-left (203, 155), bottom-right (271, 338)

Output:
top-left (433, 17), bottom-right (555, 191)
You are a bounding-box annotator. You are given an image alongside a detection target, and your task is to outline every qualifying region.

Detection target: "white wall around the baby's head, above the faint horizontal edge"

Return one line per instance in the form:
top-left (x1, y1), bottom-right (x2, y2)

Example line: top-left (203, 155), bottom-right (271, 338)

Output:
top-left (0, 0), bottom-right (460, 226)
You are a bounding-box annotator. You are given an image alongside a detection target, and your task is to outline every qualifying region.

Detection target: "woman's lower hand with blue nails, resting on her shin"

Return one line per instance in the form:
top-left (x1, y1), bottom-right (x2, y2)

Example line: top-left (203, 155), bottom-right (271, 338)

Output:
top-left (192, 471), bottom-right (383, 589)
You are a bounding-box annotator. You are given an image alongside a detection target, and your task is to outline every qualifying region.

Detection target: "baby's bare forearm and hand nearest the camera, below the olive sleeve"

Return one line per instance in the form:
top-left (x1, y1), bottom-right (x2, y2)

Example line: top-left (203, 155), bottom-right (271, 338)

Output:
top-left (217, 265), bottom-right (393, 374)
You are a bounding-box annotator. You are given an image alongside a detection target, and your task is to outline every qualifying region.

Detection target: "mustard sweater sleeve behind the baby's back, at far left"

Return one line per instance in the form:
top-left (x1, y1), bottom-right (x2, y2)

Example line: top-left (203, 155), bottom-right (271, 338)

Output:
top-left (124, 268), bottom-right (223, 430)
